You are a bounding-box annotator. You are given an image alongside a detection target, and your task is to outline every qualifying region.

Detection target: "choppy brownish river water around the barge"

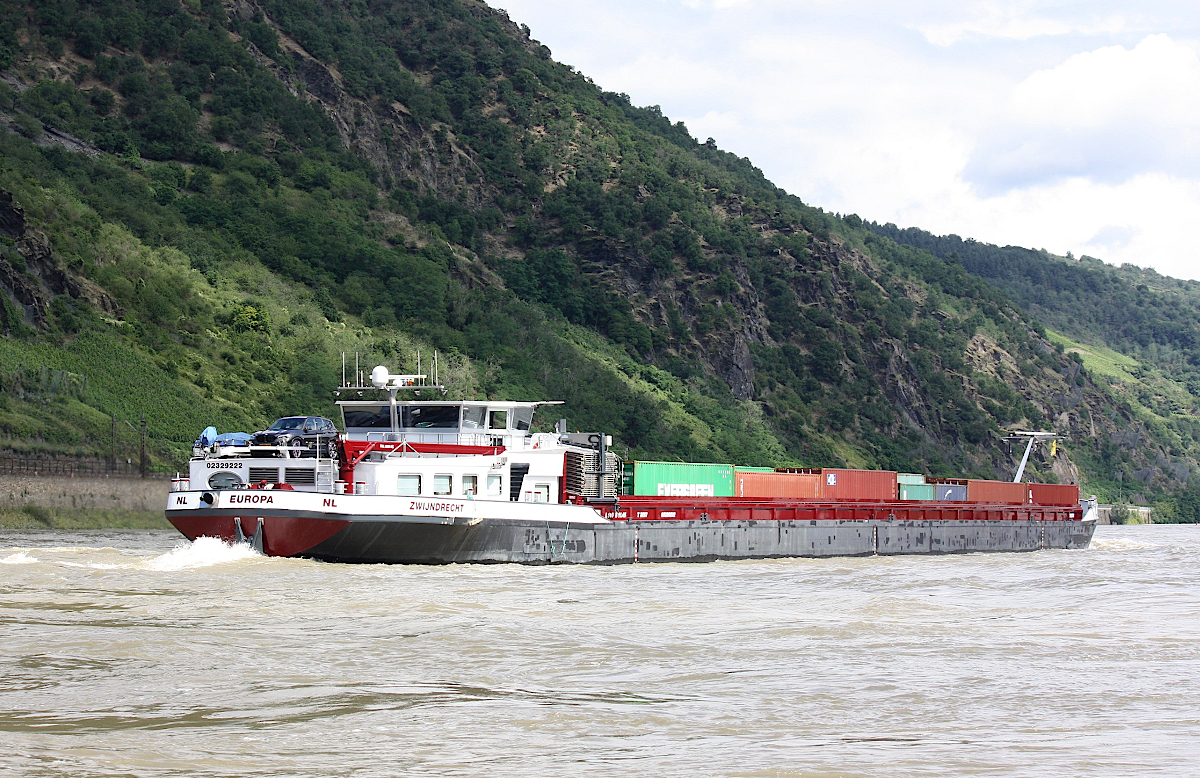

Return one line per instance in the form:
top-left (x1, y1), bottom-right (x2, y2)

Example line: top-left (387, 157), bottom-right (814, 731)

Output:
top-left (0, 526), bottom-right (1200, 778)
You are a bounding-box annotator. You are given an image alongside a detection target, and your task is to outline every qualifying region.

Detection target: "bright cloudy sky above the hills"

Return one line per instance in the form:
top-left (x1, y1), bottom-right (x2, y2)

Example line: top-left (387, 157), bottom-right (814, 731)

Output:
top-left (491, 0), bottom-right (1200, 280)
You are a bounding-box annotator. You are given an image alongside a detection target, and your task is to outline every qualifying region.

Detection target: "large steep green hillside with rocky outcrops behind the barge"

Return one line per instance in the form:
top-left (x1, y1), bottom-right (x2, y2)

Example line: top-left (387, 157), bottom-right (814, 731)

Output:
top-left (0, 0), bottom-right (1200, 514)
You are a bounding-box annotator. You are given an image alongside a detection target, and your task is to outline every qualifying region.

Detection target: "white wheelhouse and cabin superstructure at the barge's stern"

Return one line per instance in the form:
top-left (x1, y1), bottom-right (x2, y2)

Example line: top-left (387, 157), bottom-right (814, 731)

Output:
top-left (176, 366), bottom-right (620, 504)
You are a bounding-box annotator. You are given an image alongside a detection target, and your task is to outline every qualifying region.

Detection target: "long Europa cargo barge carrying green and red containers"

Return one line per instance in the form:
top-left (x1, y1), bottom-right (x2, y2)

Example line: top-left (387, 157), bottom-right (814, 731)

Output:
top-left (167, 366), bottom-right (1096, 564)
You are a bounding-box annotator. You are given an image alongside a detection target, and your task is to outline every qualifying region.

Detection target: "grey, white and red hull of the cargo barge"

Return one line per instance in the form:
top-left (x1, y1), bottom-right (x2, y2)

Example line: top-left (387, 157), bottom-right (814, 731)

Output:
top-left (167, 493), bottom-right (1096, 564)
